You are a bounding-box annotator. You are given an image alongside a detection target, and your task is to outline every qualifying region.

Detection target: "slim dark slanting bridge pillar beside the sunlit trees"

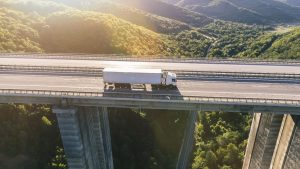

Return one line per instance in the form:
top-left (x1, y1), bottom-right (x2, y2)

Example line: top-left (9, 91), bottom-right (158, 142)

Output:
top-left (176, 111), bottom-right (198, 169)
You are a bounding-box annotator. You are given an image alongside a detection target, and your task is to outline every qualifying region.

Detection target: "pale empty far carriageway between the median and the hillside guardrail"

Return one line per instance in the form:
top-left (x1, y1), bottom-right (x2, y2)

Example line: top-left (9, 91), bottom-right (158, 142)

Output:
top-left (0, 57), bottom-right (300, 74)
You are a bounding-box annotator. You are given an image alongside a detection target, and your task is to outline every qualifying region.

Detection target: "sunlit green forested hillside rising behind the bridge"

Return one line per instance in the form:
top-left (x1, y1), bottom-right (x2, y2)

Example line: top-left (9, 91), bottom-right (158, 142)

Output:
top-left (0, 0), bottom-right (299, 58)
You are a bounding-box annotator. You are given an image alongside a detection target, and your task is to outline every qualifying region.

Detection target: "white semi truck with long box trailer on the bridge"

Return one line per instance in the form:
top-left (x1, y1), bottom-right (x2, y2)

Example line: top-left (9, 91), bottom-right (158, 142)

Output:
top-left (103, 68), bottom-right (177, 87)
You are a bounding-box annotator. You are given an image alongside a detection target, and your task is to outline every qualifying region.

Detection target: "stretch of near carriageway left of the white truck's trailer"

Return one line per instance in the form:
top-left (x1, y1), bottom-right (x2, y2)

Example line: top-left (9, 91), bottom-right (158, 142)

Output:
top-left (0, 74), bottom-right (103, 92)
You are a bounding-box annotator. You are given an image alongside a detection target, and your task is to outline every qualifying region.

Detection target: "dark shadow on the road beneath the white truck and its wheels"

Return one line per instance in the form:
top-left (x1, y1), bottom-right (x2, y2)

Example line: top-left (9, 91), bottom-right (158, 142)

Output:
top-left (103, 85), bottom-right (183, 100)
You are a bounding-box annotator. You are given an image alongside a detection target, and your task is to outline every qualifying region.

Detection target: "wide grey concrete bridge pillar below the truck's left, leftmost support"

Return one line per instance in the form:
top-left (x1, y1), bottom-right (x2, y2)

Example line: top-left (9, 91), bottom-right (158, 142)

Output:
top-left (53, 107), bottom-right (113, 169)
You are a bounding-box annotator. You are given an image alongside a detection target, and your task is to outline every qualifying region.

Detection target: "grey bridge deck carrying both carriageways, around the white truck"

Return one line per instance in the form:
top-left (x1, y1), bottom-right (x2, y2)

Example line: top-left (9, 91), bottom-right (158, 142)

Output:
top-left (0, 55), bottom-right (300, 110)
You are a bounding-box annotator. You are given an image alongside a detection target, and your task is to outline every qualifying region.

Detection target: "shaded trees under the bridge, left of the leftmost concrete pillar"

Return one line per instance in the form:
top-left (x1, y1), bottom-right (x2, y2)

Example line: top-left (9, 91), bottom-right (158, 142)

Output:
top-left (0, 104), bottom-right (66, 169)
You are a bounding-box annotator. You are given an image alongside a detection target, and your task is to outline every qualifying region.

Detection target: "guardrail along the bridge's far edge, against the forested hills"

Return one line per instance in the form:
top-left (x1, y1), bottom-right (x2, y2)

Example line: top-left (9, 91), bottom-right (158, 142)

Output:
top-left (0, 53), bottom-right (300, 66)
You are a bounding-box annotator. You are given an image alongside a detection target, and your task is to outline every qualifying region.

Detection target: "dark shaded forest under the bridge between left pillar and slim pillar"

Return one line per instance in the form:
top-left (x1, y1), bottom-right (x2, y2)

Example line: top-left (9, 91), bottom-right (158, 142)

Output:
top-left (109, 109), bottom-right (187, 169)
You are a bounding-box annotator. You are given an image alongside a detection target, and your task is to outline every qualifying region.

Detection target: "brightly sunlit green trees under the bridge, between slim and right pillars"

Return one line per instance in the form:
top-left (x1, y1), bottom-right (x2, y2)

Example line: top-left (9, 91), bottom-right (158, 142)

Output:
top-left (191, 112), bottom-right (251, 169)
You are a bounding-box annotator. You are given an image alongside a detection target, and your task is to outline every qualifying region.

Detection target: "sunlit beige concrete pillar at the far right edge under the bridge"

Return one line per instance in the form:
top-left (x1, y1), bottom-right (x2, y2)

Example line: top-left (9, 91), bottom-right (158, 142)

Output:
top-left (270, 114), bottom-right (300, 169)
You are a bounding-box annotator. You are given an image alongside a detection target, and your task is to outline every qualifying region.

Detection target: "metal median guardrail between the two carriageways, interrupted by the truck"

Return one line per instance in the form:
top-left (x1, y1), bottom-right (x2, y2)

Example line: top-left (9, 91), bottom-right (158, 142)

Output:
top-left (0, 65), bottom-right (300, 81)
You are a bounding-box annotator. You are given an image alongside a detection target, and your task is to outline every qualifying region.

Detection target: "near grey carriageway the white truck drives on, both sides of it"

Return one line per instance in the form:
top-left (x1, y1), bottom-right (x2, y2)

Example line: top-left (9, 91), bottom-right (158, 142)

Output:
top-left (0, 74), bottom-right (300, 100)
